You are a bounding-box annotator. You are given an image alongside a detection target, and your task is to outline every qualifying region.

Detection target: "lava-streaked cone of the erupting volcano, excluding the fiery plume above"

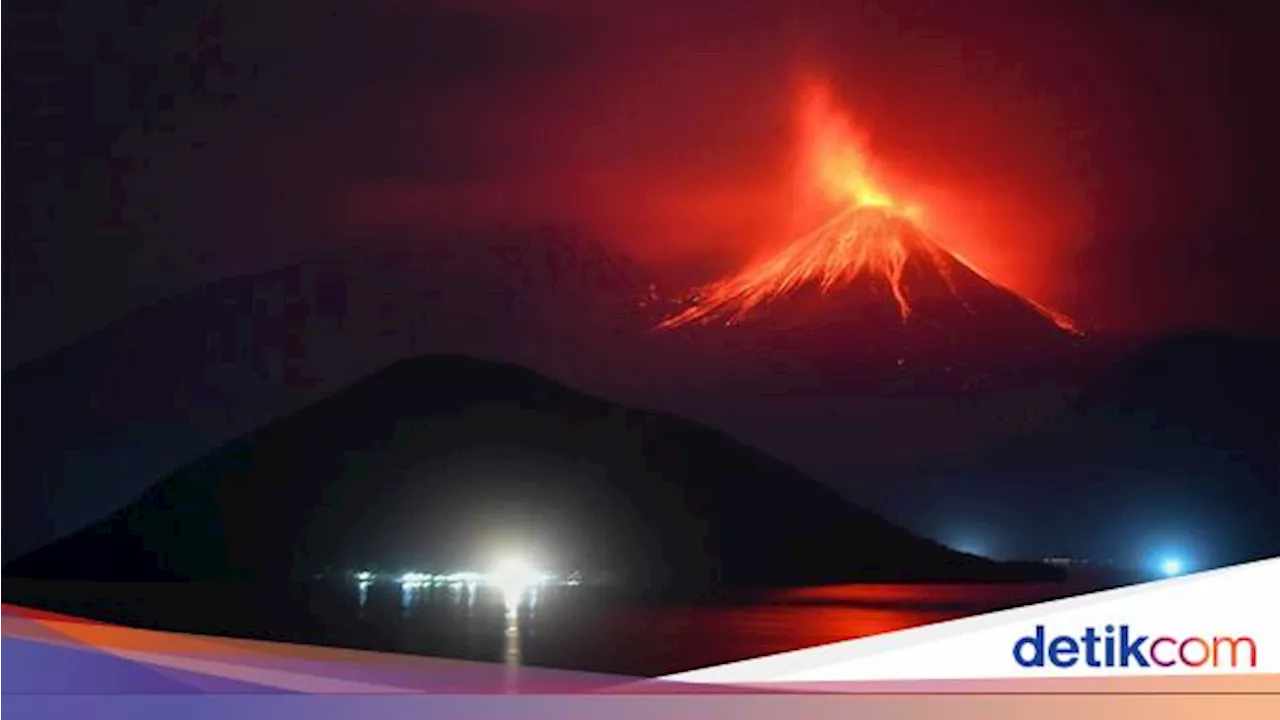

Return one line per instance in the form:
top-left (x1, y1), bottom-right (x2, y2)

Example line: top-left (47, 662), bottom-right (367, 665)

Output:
top-left (650, 208), bottom-right (1084, 395)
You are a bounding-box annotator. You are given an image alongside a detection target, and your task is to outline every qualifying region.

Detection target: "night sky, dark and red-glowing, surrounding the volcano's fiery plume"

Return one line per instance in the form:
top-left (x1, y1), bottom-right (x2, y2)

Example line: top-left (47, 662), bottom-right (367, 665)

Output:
top-left (0, 0), bottom-right (1280, 365)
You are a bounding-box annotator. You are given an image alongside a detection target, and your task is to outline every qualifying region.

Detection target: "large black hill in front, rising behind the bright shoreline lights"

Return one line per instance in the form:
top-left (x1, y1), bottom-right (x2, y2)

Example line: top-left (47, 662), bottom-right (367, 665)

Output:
top-left (4, 356), bottom-right (1054, 589)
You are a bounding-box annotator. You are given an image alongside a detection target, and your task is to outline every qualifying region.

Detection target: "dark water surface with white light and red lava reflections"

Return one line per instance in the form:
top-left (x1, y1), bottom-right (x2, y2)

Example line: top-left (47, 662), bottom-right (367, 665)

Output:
top-left (0, 580), bottom-right (1136, 676)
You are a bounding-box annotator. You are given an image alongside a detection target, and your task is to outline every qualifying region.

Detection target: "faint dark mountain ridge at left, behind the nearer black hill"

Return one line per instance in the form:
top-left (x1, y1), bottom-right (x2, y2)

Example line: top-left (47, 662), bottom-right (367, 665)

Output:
top-left (0, 229), bottom-right (657, 561)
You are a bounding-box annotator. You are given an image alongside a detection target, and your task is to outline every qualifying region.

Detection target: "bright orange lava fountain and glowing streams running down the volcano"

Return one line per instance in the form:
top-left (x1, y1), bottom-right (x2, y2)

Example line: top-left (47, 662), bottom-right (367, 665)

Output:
top-left (659, 80), bottom-right (1079, 334)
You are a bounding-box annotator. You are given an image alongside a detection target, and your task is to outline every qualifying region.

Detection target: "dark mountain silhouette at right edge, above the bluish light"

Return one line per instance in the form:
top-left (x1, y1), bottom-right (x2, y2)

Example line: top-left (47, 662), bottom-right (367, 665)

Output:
top-left (914, 333), bottom-right (1280, 562)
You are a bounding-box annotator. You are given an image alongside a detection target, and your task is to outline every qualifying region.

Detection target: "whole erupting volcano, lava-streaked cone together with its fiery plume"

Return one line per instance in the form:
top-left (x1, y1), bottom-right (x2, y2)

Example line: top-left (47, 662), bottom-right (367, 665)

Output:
top-left (659, 78), bottom-right (1079, 395)
